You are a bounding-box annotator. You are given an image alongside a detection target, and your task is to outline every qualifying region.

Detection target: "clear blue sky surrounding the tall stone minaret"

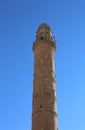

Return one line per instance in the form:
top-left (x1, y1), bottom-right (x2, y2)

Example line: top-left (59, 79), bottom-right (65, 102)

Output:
top-left (0, 0), bottom-right (85, 130)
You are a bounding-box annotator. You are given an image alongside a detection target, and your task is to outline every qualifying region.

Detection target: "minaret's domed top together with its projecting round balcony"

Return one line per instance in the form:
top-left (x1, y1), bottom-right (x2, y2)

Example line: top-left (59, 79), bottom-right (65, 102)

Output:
top-left (33, 23), bottom-right (56, 51)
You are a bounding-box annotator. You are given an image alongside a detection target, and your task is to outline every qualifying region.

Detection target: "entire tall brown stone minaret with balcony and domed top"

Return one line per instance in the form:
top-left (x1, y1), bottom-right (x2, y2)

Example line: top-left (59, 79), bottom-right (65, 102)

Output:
top-left (32, 23), bottom-right (58, 130)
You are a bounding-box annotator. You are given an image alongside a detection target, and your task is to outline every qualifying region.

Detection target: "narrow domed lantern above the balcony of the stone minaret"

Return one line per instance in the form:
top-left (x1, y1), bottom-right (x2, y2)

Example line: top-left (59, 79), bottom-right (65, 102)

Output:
top-left (36, 23), bottom-right (53, 41)
